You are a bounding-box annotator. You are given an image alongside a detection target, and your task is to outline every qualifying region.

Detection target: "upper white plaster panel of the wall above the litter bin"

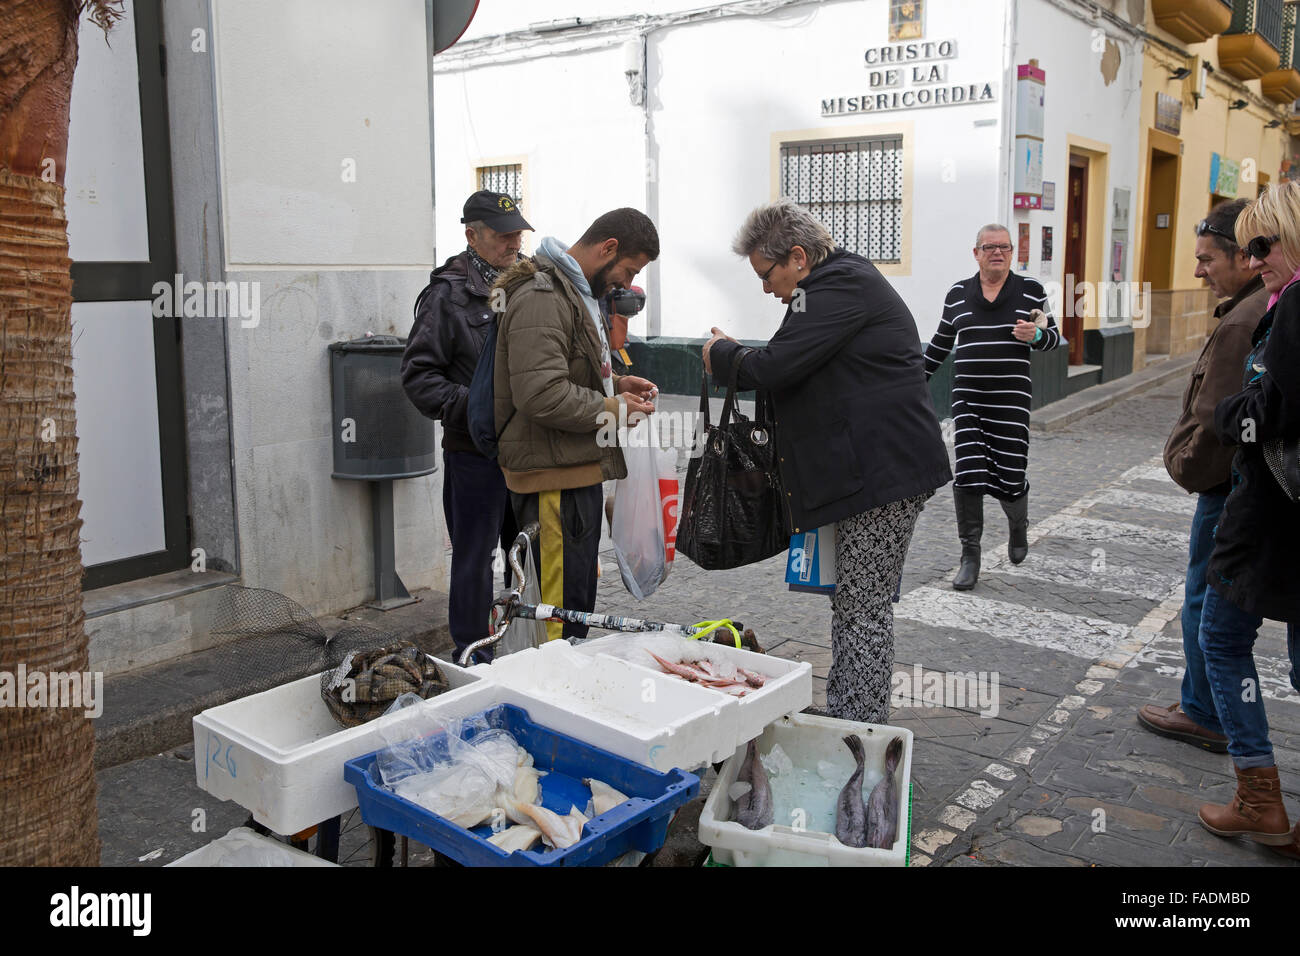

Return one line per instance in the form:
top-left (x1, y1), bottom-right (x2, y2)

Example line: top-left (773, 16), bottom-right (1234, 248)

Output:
top-left (213, 0), bottom-right (432, 268)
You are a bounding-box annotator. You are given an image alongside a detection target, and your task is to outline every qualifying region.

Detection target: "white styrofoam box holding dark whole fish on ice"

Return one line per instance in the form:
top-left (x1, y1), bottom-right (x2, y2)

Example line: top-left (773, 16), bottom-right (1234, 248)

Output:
top-left (699, 714), bottom-right (913, 866)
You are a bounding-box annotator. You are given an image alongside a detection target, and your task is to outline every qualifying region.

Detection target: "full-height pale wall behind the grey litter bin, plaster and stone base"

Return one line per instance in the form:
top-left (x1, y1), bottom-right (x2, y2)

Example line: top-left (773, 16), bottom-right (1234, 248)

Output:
top-left (213, 0), bottom-right (445, 614)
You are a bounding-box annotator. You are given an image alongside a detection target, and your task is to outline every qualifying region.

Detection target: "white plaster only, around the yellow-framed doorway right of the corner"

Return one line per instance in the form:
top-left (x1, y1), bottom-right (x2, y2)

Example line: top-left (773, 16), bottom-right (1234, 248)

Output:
top-left (1009, 0), bottom-right (1154, 282)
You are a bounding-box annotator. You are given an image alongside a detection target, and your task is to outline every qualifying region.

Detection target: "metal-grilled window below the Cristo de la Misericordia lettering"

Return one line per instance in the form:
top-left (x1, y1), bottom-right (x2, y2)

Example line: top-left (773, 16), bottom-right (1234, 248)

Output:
top-left (780, 137), bottom-right (902, 263)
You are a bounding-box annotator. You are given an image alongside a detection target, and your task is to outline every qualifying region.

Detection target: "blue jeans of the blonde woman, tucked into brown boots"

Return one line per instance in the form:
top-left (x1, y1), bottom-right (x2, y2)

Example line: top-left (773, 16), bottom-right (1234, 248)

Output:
top-left (1200, 587), bottom-right (1300, 770)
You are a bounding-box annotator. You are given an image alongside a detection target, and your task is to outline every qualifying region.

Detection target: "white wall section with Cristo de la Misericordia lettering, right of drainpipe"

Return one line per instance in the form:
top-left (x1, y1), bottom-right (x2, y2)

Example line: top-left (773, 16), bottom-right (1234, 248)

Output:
top-left (651, 0), bottom-right (1011, 341)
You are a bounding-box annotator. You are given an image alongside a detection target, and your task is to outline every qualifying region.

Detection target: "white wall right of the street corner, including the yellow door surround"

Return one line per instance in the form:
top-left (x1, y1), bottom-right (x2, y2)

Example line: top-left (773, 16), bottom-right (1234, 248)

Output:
top-left (1008, 0), bottom-right (1144, 319)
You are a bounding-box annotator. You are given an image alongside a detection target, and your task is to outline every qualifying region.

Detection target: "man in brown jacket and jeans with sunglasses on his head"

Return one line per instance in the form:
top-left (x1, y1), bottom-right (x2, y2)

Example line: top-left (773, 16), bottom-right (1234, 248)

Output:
top-left (1138, 199), bottom-right (1269, 753)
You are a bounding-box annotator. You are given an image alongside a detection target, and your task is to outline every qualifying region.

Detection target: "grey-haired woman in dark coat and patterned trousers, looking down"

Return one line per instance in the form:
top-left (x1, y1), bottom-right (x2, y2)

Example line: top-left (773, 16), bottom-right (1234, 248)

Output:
top-left (705, 199), bottom-right (952, 723)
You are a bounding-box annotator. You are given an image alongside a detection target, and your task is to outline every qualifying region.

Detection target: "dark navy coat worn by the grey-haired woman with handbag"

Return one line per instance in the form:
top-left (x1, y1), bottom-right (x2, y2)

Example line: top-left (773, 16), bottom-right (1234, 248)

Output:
top-left (709, 248), bottom-right (953, 532)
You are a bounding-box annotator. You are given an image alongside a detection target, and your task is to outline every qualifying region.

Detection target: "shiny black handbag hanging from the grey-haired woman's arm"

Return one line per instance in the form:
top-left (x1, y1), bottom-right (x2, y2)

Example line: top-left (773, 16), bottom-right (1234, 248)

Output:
top-left (677, 360), bottom-right (790, 571)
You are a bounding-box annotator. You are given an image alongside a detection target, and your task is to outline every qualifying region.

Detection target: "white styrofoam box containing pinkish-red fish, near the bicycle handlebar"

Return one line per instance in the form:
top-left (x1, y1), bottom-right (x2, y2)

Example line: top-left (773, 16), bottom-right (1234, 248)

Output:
top-left (577, 631), bottom-right (813, 752)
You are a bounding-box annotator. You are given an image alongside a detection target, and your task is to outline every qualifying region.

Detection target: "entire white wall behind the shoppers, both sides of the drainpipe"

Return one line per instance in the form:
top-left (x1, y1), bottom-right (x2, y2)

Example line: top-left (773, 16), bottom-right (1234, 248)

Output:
top-left (436, 0), bottom-right (1009, 338)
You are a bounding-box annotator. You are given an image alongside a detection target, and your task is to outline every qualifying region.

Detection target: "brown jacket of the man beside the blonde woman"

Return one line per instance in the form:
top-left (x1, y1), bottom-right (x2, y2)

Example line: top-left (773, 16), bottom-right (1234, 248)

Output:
top-left (1165, 276), bottom-right (1269, 494)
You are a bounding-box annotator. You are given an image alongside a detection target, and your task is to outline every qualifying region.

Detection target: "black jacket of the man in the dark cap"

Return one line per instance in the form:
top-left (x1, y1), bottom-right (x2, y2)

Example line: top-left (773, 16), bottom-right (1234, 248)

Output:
top-left (402, 252), bottom-right (495, 455)
